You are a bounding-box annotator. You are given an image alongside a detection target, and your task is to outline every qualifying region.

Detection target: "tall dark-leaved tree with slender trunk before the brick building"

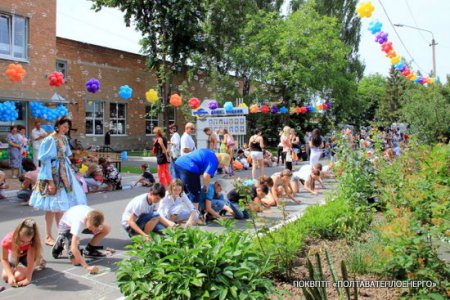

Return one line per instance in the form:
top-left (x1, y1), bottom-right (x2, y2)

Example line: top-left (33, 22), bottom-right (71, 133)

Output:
top-left (93, 0), bottom-right (206, 126)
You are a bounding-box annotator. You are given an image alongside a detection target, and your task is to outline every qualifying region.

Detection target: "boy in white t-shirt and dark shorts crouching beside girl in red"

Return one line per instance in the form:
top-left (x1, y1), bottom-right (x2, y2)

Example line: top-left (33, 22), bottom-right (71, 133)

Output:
top-left (52, 205), bottom-right (111, 274)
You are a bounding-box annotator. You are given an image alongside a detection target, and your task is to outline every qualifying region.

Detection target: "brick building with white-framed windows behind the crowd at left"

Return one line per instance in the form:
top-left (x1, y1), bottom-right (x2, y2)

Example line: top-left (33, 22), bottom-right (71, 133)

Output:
top-left (0, 0), bottom-right (214, 150)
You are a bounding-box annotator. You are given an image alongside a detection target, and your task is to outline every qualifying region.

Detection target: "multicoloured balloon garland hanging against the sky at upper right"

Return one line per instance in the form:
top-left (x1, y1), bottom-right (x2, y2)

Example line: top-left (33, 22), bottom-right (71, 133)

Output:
top-left (356, 1), bottom-right (434, 85)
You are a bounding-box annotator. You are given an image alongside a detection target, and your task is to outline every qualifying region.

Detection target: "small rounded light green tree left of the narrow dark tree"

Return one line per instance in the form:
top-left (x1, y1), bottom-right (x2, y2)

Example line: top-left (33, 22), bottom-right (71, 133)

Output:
top-left (356, 73), bottom-right (387, 126)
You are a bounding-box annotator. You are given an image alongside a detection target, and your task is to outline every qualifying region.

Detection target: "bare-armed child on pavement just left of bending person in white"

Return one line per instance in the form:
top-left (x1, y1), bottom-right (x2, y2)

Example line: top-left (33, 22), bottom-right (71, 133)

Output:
top-left (262, 169), bottom-right (301, 206)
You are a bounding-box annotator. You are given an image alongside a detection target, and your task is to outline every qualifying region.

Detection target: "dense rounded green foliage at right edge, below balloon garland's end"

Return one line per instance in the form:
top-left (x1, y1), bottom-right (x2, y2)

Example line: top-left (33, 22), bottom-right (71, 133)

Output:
top-left (401, 86), bottom-right (450, 144)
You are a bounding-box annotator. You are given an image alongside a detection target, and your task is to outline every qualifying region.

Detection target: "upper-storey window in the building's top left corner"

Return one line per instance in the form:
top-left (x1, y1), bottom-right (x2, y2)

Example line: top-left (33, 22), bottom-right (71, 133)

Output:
top-left (0, 13), bottom-right (28, 60)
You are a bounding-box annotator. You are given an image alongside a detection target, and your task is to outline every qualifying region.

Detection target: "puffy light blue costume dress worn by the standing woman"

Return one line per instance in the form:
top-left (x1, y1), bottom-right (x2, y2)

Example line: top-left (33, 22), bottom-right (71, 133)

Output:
top-left (30, 133), bottom-right (87, 212)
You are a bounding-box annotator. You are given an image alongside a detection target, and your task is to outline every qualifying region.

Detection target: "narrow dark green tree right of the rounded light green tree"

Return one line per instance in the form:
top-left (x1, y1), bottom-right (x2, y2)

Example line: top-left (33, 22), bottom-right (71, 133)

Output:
top-left (376, 66), bottom-right (412, 126)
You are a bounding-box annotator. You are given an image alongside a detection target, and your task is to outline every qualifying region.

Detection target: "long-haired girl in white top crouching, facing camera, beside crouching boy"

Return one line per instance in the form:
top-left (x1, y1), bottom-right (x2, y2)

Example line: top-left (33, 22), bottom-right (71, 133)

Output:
top-left (158, 179), bottom-right (199, 226)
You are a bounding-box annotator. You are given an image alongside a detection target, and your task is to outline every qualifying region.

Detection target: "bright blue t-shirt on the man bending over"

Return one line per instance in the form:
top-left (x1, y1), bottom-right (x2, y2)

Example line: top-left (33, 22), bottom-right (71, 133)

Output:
top-left (175, 149), bottom-right (219, 177)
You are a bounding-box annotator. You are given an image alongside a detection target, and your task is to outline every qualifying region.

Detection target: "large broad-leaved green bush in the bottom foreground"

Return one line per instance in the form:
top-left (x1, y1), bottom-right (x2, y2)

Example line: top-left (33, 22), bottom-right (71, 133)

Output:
top-left (116, 229), bottom-right (274, 299)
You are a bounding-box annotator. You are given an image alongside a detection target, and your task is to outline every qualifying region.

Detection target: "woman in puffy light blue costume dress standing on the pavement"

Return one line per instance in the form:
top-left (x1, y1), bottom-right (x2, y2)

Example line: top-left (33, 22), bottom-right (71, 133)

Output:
top-left (30, 117), bottom-right (87, 246)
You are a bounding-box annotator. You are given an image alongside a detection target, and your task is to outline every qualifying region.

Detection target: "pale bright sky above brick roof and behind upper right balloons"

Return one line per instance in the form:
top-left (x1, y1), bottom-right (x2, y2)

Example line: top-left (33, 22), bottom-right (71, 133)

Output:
top-left (57, 0), bottom-right (450, 82)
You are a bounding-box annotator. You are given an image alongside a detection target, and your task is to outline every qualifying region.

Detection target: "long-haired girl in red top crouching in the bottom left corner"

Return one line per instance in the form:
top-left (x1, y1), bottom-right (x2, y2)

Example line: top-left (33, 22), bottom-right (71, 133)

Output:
top-left (2, 219), bottom-right (45, 287)
